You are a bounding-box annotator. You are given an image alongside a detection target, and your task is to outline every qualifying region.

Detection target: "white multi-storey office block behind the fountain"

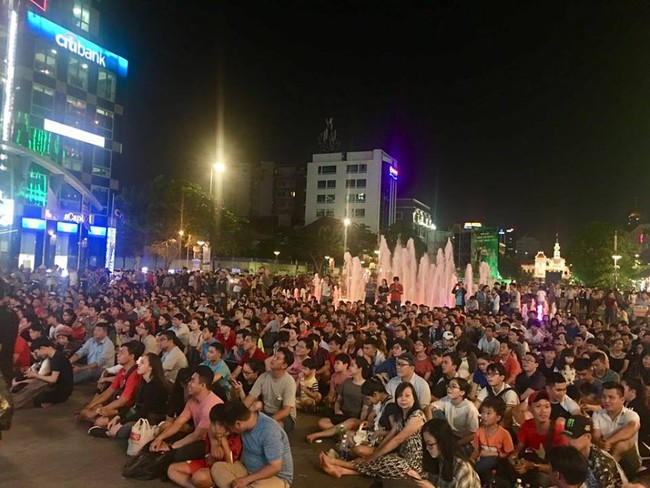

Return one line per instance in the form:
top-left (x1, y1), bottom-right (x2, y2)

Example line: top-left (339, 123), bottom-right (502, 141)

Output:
top-left (305, 149), bottom-right (399, 232)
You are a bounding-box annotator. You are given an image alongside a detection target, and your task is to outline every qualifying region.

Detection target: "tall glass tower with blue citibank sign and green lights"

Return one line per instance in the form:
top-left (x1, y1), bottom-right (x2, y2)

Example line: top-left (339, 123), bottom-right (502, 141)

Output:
top-left (0, 0), bottom-right (128, 269)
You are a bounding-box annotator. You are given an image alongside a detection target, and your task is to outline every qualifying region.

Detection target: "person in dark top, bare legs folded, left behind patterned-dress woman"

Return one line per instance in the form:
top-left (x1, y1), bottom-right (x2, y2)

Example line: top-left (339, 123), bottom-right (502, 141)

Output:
top-left (307, 355), bottom-right (370, 442)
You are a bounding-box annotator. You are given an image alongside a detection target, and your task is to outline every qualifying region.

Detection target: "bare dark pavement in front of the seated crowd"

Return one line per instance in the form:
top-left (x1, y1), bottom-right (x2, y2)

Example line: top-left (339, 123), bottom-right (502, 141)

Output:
top-left (0, 385), bottom-right (371, 488)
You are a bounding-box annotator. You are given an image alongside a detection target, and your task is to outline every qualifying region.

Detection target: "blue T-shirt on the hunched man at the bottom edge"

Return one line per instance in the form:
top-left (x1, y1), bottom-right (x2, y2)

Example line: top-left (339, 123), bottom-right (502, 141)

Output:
top-left (241, 412), bottom-right (293, 485)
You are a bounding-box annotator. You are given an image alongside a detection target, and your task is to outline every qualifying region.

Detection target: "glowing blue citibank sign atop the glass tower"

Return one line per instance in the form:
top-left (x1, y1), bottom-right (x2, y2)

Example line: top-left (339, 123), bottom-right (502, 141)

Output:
top-left (27, 10), bottom-right (129, 78)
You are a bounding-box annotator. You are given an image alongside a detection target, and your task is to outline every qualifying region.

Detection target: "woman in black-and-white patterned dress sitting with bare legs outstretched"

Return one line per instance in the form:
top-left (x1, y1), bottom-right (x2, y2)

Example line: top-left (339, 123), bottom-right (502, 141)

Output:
top-left (320, 382), bottom-right (426, 479)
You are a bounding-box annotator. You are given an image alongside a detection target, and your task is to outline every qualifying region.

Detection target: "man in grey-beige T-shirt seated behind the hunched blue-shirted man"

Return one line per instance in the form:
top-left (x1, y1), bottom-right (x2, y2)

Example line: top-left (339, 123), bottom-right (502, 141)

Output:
top-left (244, 348), bottom-right (296, 432)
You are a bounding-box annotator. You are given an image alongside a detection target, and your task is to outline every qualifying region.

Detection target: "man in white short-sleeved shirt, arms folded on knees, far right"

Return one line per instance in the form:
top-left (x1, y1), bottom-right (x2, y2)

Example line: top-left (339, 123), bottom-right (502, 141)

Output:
top-left (592, 382), bottom-right (641, 477)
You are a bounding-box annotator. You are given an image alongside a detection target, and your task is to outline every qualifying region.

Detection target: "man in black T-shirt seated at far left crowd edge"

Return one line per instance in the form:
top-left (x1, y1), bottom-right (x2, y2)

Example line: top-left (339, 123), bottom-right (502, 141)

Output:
top-left (17, 337), bottom-right (73, 407)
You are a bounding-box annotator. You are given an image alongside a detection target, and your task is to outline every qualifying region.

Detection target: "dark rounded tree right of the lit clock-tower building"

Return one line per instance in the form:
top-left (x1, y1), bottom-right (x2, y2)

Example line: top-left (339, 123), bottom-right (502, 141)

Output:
top-left (567, 222), bottom-right (636, 287)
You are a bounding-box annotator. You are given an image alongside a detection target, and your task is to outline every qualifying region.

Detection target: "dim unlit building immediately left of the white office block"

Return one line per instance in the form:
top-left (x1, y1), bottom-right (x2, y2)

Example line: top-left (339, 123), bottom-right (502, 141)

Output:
top-left (273, 164), bottom-right (307, 227)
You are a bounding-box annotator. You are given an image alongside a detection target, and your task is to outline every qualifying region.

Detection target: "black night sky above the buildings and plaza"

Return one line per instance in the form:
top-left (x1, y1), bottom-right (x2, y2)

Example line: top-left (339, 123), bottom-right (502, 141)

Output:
top-left (103, 0), bottom-right (650, 248)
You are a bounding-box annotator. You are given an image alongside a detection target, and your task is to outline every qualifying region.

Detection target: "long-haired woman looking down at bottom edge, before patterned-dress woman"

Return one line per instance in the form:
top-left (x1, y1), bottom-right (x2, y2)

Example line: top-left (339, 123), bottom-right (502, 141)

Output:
top-left (405, 419), bottom-right (481, 488)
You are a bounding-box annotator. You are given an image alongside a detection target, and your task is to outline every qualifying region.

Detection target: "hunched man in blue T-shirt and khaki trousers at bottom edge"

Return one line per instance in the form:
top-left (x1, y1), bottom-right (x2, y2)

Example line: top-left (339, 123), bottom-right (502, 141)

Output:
top-left (210, 400), bottom-right (293, 488)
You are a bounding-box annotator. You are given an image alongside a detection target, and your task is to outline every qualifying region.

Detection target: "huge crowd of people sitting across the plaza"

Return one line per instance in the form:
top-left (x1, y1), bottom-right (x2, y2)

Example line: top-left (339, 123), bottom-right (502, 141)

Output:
top-left (0, 268), bottom-right (650, 488)
